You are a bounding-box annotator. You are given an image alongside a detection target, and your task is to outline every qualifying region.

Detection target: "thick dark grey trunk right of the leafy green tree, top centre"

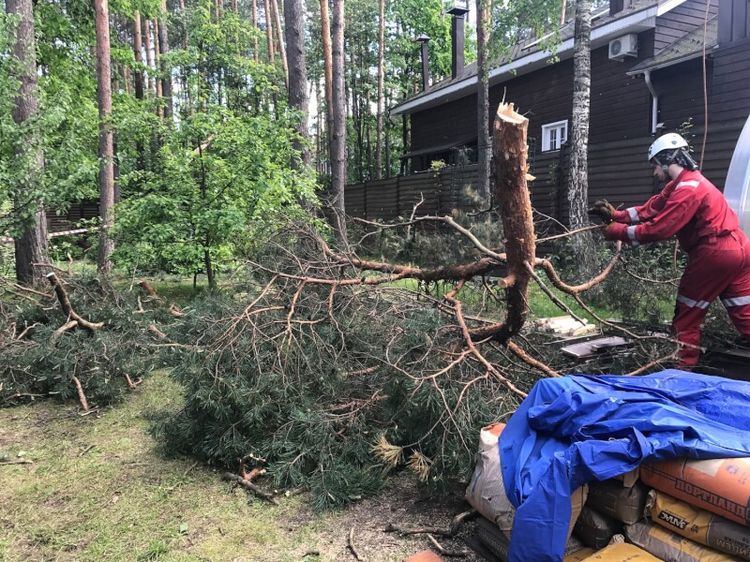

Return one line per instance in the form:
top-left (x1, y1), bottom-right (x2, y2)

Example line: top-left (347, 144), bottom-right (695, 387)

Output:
top-left (284, 0), bottom-right (310, 166)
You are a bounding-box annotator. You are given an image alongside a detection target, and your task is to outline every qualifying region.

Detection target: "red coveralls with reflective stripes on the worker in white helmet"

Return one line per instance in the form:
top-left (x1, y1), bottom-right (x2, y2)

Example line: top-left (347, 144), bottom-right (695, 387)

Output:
top-left (605, 170), bottom-right (750, 366)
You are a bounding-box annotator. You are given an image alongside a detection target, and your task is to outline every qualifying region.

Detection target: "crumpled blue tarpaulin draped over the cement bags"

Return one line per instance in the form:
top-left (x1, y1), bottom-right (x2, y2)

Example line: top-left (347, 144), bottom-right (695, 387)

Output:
top-left (500, 369), bottom-right (750, 562)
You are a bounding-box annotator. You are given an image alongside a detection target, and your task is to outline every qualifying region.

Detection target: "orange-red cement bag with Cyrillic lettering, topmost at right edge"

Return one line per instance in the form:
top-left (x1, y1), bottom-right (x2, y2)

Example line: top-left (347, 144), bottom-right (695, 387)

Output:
top-left (640, 457), bottom-right (750, 526)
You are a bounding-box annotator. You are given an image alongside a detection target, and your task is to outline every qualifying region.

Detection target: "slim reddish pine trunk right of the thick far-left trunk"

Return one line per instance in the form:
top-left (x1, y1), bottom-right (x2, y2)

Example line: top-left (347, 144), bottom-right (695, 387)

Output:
top-left (94, 0), bottom-right (115, 275)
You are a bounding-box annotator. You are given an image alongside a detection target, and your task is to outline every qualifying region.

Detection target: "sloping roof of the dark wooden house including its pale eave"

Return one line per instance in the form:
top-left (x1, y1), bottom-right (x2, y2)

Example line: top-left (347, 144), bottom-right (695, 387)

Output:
top-left (391, 0), bottom-right (685, 115)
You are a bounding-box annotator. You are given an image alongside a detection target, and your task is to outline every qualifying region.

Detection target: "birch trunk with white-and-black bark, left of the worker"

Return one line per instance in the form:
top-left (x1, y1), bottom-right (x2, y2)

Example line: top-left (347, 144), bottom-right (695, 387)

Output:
top-left (568, 0), bottom-right (596, 276)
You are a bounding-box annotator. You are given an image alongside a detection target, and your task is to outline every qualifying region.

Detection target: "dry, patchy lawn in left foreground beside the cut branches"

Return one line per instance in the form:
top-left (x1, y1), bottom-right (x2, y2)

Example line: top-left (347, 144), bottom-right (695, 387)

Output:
top-left (0, 373), bottom-right (320, 562)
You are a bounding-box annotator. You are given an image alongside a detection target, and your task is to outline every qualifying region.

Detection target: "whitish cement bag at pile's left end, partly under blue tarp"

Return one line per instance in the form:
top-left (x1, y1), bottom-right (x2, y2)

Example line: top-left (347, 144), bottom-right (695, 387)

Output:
top-left (466, 423), bottom-right (587, 538)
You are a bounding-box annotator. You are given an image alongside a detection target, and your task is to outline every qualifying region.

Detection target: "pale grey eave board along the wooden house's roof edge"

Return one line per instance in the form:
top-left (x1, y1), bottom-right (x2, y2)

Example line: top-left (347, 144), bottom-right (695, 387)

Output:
top-left (390, 0), bottom-right (686, 115)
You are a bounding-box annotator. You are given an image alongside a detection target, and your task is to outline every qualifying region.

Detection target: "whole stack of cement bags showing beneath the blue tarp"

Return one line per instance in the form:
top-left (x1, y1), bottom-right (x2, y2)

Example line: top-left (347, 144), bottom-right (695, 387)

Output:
top-left (466, 424), bottom-right (750, 562)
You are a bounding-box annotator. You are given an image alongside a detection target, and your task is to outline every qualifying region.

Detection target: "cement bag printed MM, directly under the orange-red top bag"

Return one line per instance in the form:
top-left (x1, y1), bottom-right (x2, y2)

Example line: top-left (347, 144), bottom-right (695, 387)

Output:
top-left (648, 490), bottom-right (750, 560)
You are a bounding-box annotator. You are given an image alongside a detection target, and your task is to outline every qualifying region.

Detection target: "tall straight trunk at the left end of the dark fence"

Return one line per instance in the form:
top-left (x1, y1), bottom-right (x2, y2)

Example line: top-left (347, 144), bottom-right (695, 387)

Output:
top-left (331, 0), bottom-right (347, 246)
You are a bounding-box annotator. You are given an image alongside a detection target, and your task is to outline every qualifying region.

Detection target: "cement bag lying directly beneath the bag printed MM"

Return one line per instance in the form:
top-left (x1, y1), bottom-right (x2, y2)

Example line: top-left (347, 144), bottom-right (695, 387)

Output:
top-left (625, 522), bottom-right (742, 562)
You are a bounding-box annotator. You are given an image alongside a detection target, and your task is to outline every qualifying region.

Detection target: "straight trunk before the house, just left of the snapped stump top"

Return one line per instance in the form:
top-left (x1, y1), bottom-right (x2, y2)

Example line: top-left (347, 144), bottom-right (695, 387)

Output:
top-left (477, 0), bottom-right (492, 201)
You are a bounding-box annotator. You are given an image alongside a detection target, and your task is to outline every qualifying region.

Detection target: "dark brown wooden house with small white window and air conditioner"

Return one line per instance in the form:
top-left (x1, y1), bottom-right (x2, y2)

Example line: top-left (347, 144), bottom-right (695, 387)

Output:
top-left (346, 0), bottom-right (750, 221)
